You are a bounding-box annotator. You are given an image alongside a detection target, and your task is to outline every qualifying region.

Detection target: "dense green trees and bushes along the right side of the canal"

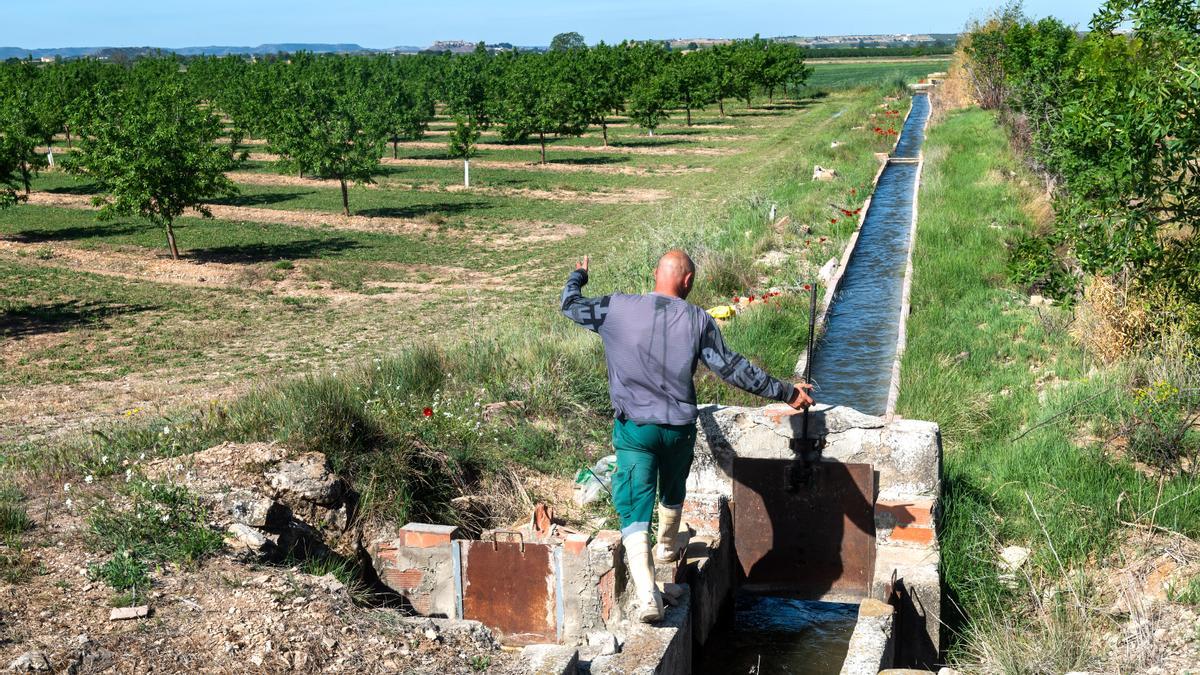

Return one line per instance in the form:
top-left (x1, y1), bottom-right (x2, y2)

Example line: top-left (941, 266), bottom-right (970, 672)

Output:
top-left (964, 0), bottom-right (1200, 339)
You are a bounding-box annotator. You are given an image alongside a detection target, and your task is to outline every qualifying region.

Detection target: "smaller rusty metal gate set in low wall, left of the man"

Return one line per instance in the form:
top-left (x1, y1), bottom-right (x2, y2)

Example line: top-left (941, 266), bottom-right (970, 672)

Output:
top-left (458, 533), bottom-right (563, 645)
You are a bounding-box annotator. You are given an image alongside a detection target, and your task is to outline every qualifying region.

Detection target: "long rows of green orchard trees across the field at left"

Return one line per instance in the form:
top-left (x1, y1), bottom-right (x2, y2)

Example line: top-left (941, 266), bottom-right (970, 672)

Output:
top-left (0, 36), bottom-right (809, 257)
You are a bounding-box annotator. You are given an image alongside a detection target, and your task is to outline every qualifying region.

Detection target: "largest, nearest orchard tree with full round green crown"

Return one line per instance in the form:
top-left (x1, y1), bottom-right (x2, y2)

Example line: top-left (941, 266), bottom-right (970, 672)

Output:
top-left (64, 60), bottom-right (238, 259)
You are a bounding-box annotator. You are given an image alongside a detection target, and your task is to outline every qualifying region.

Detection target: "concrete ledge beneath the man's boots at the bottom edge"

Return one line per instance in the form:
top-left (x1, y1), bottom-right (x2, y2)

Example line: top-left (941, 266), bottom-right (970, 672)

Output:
top-left (590, 593), bottom-right (692, 675)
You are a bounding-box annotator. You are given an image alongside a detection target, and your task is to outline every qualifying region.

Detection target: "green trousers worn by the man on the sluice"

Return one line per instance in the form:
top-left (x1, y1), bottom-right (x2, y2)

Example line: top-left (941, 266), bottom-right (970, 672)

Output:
top-left (612, 419), bottom-right (696, 537)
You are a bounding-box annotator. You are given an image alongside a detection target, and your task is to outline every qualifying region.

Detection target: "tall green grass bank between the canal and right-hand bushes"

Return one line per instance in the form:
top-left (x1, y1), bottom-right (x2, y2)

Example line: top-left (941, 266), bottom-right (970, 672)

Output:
top-left (898, 109), bottom-right (1200, 673)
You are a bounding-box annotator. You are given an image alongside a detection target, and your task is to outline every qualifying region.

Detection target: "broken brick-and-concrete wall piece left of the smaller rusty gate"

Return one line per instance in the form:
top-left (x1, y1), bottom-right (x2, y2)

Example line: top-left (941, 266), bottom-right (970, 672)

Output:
top-left (368, 522), bottom-right (461, 619)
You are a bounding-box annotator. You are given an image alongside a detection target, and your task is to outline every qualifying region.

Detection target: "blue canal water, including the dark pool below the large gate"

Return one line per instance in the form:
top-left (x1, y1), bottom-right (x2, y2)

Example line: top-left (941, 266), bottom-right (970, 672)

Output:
top-left (696, 95), bottom-right (929, 675)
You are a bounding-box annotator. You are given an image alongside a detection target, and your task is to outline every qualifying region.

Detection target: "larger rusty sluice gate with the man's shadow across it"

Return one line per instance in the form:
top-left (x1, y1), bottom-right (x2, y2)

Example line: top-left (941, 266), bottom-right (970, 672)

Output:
top-left (733, 458), bottom-right (875, 601)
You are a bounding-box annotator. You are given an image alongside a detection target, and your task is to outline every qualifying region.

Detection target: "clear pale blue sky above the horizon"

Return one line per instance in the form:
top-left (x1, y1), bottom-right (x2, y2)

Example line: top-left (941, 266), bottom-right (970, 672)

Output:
top-left (0, 0), bottom-right (1100, 49)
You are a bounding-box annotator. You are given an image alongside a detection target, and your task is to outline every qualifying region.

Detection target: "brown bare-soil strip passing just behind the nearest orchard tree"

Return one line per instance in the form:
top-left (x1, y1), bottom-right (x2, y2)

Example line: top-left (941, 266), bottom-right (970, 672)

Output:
top-left (29, 192), bottom-right (586, 249)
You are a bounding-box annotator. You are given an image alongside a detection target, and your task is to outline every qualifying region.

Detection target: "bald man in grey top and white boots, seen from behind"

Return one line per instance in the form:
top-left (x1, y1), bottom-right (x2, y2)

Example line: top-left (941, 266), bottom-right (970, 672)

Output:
top-left (563, 250), bottom-right (812, 622)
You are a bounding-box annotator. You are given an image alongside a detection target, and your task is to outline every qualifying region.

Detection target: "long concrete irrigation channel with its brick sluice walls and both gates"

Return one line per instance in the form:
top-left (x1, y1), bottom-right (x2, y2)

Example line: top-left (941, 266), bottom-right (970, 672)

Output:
top-left (368, 86), bottom-right (942, 675)
